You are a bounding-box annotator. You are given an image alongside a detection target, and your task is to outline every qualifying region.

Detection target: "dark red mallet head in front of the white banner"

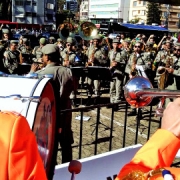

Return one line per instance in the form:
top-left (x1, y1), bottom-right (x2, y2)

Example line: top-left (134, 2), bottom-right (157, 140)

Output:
top-left (68, 160), bottom-right (82, 180)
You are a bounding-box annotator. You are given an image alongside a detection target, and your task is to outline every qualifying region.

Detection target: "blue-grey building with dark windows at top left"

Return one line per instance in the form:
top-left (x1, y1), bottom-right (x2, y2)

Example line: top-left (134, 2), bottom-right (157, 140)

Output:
top-left (12, 0), bottom-right (56, 25)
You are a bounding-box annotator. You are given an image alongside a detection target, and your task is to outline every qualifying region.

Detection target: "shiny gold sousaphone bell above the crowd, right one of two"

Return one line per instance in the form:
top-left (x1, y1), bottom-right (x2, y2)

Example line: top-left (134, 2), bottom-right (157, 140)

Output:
top-left (79, 22), bottom-right (98, 41)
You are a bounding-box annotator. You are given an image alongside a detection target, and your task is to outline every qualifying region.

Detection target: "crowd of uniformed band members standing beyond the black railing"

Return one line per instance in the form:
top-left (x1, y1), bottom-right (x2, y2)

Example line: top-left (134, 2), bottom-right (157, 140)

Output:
top-left (0, 23), bottom-right (180, 162)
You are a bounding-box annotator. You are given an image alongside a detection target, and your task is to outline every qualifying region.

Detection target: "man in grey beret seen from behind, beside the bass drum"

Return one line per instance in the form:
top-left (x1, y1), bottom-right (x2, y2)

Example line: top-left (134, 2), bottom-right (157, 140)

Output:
top-left (31, 44), bottom-right (74, 163)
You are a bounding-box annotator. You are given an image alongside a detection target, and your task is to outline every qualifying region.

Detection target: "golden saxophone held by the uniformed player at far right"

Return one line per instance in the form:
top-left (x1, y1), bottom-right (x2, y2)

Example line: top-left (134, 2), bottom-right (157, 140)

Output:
top-left (157, 53), bottom-right (173, 89)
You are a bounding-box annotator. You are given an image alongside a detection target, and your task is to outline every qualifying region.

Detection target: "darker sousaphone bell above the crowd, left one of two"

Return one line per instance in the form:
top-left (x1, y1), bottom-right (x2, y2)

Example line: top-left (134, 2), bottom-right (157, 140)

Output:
top-left (57, 22), bottom-right (75, 40)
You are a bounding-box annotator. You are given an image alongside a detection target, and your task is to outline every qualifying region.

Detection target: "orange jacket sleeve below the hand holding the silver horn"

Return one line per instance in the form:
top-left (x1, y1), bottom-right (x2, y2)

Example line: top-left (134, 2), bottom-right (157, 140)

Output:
top-left (116, 129), bottom-right (180, 180)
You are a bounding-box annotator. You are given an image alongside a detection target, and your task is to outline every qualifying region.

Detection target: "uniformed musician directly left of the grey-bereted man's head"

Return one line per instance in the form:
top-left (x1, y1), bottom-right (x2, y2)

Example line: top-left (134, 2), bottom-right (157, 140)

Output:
top-left (32, 38), bottom-right (47, 62)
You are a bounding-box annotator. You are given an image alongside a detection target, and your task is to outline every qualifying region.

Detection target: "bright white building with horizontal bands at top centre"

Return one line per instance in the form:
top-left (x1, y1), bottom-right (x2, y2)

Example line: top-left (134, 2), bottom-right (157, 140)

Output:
top-left (88, 0), bottom-right (130, 24)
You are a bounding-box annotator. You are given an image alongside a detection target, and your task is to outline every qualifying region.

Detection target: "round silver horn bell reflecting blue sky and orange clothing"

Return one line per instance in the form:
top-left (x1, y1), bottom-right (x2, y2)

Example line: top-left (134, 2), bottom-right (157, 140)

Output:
top-left (124, 76), bottom-right (153, 108)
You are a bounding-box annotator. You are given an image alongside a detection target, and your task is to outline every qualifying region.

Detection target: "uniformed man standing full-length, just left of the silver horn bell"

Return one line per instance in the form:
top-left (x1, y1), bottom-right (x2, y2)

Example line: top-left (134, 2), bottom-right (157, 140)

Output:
top-left (108, 39), bottom-right (127, 103)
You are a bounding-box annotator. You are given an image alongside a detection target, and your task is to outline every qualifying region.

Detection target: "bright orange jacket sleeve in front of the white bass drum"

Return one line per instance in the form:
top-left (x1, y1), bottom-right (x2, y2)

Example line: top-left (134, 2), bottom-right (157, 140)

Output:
top-left (0, 112), bottom-right (47, 180)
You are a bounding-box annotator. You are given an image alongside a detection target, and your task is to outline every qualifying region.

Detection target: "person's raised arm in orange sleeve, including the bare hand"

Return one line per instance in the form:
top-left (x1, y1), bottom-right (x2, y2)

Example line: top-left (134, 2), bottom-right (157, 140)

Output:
top-left (115, 98), bottom-right (180, 180)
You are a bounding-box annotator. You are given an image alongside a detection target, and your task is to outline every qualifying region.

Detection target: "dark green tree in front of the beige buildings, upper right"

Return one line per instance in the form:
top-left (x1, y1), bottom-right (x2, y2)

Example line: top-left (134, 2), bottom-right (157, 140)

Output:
top-left (147, 2), bottom-right (161, 25)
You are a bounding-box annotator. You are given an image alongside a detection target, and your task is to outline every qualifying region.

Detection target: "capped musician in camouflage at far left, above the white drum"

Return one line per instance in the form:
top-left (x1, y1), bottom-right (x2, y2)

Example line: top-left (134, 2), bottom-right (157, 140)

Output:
top-left (3, 40), bottom-right (22, 74)
